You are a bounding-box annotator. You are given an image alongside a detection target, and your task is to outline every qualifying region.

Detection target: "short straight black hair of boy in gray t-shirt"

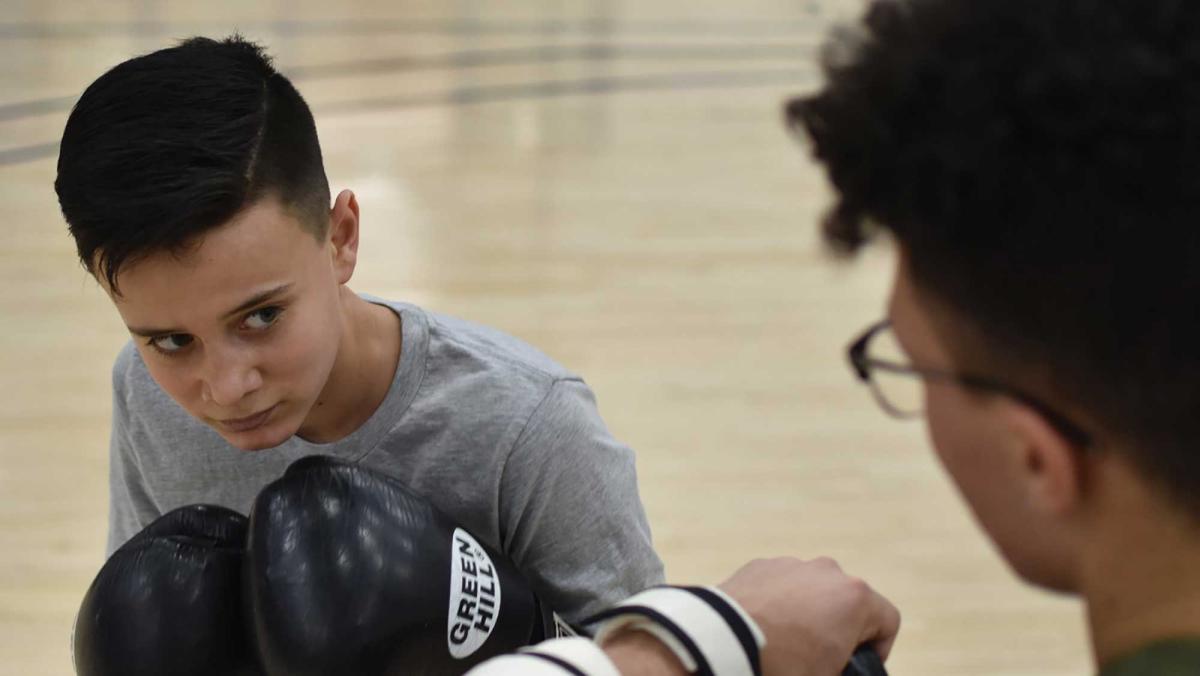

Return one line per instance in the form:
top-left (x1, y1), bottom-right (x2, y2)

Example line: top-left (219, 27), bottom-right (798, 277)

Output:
top-left (54, 35), bottom-right (329, 293)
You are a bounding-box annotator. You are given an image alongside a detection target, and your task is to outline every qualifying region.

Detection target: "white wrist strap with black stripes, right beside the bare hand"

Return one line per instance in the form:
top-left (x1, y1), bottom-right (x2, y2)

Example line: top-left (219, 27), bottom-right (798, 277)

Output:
top-left (588, 587), bottom-right (767, 676)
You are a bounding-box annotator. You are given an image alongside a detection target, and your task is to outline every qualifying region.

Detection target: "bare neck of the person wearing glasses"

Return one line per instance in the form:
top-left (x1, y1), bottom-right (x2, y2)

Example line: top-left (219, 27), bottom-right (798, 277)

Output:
top-left (1079, 463), bottom-right (1200, 665)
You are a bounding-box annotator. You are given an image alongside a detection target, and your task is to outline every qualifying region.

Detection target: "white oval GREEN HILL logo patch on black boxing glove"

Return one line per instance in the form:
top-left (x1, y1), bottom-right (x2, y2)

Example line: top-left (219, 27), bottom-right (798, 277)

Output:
top-left (446, 528), bottom-right (500, 659)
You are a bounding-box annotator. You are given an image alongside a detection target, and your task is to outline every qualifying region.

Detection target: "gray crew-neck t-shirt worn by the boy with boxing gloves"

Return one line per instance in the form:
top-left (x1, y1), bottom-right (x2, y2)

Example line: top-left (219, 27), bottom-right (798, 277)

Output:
top-left (108, 297), bottom-right (662, 622)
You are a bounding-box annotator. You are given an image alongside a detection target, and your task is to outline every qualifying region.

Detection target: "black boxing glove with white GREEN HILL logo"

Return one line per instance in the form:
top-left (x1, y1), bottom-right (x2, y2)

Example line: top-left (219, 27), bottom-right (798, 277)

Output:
top-left (244, 456), bottom-right (571, 676)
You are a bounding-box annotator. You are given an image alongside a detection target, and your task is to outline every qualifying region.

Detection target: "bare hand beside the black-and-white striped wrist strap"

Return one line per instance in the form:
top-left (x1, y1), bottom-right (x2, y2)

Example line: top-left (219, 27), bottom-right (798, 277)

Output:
top-left (720, 558), bottom-right (900, 676)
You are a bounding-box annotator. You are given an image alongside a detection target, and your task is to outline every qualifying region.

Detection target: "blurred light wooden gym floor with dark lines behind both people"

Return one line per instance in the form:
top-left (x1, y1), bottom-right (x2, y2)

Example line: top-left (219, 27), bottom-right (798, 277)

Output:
top-left (0, 0), bottom-right (1091, 676)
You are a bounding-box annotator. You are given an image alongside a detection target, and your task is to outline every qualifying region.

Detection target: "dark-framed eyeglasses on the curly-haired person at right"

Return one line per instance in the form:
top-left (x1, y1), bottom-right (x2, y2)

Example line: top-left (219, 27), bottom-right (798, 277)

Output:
top-left (846, 319), bottom-right (1092, 447)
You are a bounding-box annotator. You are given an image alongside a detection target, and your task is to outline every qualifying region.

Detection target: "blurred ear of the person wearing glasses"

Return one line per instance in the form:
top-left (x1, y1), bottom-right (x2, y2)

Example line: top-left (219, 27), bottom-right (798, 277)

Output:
top-left (1003, 402), bottom-right (1087, 516)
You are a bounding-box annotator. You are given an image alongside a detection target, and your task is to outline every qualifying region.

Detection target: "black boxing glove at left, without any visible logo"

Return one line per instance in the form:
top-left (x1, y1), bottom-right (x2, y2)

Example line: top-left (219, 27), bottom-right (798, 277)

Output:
top-left (72, 504), bottom-right (260, 676)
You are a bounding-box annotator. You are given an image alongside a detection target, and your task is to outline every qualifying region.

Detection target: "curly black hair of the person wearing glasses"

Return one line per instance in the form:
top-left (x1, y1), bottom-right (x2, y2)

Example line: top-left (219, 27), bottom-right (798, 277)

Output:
top-left (787, 0), bottom-right (1200, 515)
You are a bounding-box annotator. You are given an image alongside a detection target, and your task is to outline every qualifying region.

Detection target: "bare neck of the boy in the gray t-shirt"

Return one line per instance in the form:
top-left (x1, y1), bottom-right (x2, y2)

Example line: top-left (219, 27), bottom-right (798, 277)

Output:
top-left (296, 286), bottom-right (401, 443)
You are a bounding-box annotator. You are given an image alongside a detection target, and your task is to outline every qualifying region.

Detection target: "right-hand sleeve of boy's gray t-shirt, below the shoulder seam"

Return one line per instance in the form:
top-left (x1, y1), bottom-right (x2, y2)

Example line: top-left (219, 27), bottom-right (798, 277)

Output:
top-left (499, 378), bottom-right (664, 623)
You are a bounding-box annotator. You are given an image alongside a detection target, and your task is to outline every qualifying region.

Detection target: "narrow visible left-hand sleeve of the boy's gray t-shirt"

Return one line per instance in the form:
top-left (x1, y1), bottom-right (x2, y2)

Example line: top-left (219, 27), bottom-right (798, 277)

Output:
top-left (104, 347), bottom-right (158, 557)
